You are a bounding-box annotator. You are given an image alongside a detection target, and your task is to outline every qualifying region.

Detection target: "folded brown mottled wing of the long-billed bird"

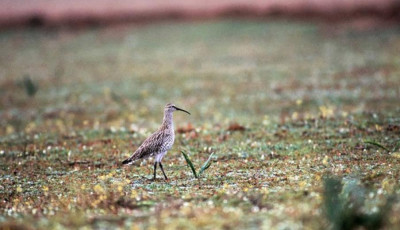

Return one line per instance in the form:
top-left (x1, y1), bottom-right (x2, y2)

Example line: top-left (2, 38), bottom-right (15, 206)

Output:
top-left (129, 132), bottom-right (166, 161)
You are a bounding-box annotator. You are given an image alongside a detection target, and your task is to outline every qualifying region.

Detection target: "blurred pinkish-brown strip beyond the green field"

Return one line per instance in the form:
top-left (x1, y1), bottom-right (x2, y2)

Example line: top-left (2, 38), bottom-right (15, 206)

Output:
top-left (0, 0), bottom-right (400, 27)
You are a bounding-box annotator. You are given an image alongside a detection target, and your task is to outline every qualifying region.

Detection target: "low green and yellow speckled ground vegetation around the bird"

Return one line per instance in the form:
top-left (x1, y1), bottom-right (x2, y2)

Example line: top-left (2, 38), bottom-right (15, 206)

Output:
top-left (0, 20), bottom-right (400, 229)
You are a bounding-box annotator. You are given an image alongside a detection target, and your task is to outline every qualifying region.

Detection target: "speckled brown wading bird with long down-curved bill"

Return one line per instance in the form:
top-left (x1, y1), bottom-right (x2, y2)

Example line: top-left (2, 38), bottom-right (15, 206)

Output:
top-left (122, 103), bottom-right (190, 180)
